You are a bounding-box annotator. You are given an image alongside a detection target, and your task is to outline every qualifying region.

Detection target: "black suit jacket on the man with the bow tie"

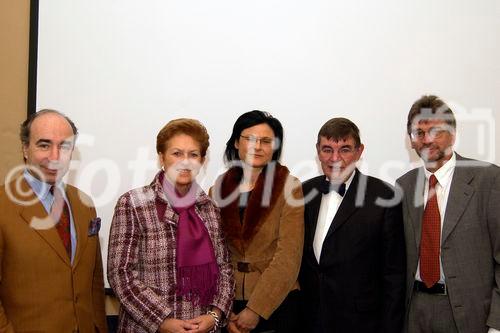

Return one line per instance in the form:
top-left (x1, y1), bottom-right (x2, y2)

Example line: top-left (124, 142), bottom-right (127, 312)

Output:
top-left (299, 170), bottom-right (405, 333)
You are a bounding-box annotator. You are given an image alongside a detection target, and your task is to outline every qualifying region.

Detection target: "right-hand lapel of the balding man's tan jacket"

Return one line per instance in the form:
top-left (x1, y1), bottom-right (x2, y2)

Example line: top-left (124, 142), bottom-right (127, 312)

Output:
top-left (66, 187), bottom-right (90, 267)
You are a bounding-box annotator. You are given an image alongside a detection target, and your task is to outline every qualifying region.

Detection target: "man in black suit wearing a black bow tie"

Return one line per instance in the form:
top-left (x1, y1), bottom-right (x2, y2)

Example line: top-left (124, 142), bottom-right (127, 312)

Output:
top-left (299, 118), bottom-right (405, 333)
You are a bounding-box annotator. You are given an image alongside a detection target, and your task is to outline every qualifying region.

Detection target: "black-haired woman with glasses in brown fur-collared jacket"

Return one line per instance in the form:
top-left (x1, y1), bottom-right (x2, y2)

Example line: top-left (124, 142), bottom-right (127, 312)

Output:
top-left (211, 111), bottom-right (304, 333)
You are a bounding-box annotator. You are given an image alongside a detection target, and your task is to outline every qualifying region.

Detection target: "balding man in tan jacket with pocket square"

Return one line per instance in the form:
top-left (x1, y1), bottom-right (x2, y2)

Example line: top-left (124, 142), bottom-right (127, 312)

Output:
top-left (0, 110), bottom-right (106, 333)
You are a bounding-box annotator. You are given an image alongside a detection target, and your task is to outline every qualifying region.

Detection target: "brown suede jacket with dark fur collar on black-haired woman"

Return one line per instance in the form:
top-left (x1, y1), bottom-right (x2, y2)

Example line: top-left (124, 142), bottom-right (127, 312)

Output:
top-left (210, 163), bottom-right (304, 319)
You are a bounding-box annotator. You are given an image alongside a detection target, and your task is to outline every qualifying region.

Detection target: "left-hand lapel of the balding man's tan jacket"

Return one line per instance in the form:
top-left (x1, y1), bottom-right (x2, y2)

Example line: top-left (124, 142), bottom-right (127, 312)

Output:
top-left (15, 176), bottom-right (71, 266)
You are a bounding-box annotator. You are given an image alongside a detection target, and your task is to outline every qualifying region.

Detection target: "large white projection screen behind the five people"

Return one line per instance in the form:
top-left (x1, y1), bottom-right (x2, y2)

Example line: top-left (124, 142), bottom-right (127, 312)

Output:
top-left (31, 0), bottom-right (500, 286)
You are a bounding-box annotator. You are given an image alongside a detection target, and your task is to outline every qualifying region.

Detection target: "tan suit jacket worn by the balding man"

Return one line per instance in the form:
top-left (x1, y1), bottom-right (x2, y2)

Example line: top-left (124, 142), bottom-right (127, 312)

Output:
top-left (0, 176), bottom-right (106, 333)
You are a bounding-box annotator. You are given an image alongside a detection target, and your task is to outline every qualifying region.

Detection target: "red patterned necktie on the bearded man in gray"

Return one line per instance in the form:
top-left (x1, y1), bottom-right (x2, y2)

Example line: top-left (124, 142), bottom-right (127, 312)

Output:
top-left (420, 175), bottom-right (441, 288)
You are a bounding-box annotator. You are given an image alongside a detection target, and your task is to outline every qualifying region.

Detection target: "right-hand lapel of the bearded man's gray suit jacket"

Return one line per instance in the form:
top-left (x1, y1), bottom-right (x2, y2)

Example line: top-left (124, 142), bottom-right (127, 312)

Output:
top-left (441, 160), bottom-right (474, 244)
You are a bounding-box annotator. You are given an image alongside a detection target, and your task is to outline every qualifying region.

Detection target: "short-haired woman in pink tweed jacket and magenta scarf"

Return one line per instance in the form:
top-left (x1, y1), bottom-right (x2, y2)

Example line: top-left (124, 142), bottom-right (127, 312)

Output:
top-left (108, 119), bottom-right (234, 333)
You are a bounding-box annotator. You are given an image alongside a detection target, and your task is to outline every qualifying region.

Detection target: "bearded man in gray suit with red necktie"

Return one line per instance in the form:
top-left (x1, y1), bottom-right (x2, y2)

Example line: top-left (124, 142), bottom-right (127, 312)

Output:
top-left (397, 96), bottom-right (500, 333)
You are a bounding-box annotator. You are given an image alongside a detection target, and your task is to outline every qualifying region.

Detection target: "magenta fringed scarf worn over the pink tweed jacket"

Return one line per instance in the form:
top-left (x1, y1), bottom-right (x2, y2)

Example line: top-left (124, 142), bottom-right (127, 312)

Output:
top-left (162, 175), bottom-right (219, 305)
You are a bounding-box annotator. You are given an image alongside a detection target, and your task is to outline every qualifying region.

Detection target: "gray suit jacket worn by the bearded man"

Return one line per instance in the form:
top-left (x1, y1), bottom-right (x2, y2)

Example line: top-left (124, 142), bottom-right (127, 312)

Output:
top-left (397, 154), bottom-right (500, 333)
